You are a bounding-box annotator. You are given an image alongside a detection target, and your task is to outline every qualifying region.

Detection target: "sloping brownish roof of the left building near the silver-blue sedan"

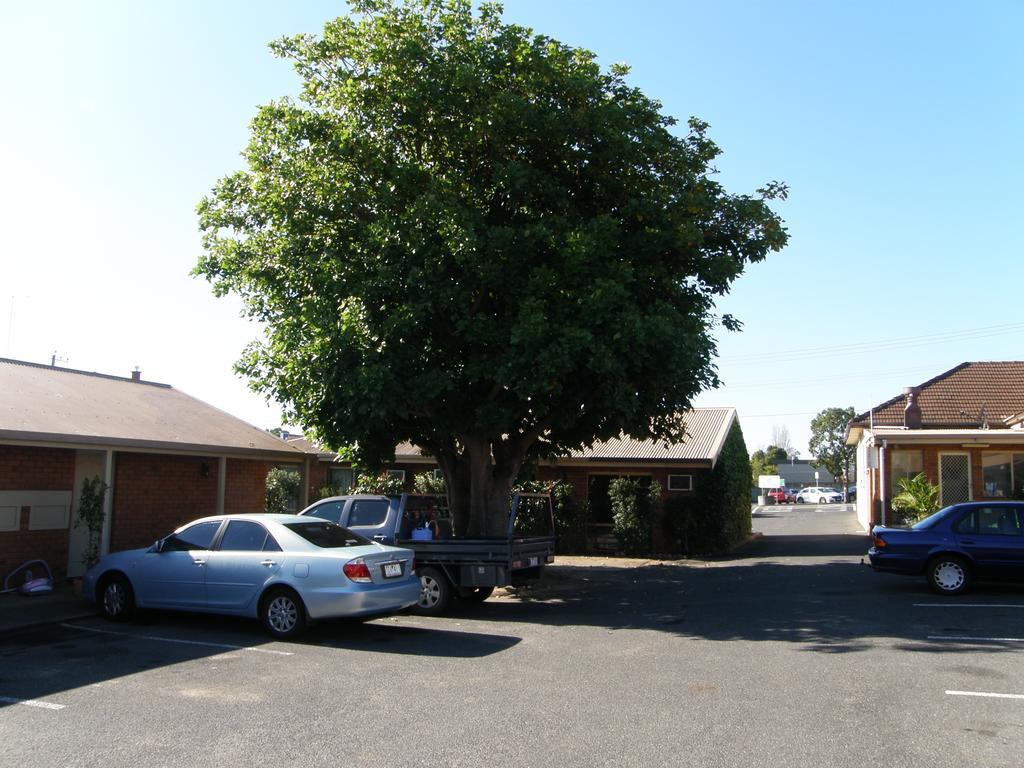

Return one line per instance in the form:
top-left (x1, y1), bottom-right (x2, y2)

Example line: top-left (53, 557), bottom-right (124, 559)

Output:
top-left (0, 357), bottom-right (300, 459)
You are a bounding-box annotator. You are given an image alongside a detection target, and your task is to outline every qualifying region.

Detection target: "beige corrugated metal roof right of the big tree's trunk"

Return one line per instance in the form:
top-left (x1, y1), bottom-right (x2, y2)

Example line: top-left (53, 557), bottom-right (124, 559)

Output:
top-left (569, 408), bottom-right (736, 465)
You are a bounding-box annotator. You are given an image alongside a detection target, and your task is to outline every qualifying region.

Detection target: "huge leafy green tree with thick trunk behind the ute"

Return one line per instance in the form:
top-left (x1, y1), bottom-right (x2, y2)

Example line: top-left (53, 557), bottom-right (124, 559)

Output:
top-left (196, 0), bottom-right (786, 535)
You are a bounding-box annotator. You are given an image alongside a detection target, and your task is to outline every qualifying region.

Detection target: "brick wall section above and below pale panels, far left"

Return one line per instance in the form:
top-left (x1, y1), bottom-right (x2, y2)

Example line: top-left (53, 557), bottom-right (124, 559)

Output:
top-left (0, 445), bottom-right (75, 584)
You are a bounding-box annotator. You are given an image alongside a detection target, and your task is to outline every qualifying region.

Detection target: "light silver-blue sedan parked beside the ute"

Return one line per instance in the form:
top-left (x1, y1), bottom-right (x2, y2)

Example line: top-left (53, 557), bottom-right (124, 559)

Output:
top-left (82, 515), bottom-right (420, 638)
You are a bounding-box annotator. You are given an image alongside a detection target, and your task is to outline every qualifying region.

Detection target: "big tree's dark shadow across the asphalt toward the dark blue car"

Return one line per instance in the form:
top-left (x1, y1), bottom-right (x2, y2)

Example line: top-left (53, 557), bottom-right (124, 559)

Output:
top-left (467, 536), bottom-right (1024, 653)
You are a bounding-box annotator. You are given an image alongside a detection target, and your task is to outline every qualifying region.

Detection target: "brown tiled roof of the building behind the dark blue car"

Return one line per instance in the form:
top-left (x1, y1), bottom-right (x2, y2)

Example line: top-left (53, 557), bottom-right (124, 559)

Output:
top-left (851, 360), bottom-right (1024, 429)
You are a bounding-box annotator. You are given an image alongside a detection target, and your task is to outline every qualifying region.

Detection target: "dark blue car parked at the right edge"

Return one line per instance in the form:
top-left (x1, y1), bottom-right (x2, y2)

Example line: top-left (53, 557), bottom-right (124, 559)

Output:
top-left (867, 502), bottom-right (1024, 595)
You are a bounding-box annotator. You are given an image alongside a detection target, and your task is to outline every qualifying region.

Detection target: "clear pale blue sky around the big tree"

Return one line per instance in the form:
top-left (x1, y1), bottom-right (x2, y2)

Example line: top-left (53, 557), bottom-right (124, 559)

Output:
top-left (0, 0), bottom-right (1024, 456)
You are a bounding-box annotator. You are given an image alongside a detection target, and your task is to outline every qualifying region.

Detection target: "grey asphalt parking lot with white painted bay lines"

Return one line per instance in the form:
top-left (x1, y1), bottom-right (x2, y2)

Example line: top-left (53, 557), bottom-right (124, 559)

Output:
top-left (0, 505), bottom-right (1024, 767)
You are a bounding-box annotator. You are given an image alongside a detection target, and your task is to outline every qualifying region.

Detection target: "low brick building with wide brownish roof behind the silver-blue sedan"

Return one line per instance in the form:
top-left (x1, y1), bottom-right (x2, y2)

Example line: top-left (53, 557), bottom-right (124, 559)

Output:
top-left (0, 358), bottom-right (305, 579)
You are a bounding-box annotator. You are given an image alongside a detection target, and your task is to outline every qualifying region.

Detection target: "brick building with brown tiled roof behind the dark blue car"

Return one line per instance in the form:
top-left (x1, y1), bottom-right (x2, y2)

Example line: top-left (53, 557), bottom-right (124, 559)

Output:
top-left (847, 361), bottom-right (1024, 528)
